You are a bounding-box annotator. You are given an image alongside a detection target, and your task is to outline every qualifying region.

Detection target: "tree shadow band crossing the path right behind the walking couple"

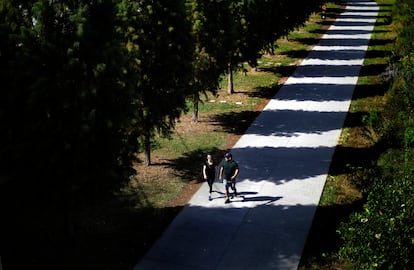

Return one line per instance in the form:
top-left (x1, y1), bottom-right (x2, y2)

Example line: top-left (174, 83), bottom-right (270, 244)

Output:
top-left (170, 139), bottom-right (378, 186)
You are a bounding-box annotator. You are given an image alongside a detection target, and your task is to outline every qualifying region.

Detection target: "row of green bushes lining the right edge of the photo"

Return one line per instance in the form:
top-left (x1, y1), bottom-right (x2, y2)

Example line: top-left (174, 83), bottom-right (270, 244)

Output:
top-left (339, 0), bottom-right (414, 269)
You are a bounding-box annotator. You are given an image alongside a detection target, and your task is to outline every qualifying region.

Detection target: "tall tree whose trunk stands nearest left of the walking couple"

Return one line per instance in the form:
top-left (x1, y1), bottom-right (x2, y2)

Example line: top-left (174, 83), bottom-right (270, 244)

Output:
top-left (118, 0), bottom-right (194, 165)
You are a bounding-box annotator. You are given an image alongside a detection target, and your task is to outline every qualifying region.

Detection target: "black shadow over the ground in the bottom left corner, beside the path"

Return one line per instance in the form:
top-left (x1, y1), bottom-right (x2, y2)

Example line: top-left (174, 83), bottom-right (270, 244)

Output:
top-left (0, 174), bottom-right (182, 270)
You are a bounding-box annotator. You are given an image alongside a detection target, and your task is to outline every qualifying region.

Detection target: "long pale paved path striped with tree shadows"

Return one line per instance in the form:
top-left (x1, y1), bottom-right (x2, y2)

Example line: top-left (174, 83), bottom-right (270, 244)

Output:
top-left (135, 0), bottom-right (378, 270)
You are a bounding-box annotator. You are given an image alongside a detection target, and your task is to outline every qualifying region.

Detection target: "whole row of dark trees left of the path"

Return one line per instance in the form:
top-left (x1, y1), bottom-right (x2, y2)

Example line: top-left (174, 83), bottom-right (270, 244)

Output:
top-left (0, 0), bottom-right (320, 196)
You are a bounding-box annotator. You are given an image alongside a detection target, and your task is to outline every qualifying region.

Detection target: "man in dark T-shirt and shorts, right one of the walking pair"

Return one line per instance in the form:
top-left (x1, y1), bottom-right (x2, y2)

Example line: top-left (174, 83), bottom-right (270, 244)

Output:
top-left (219, 153), bottom-right (239, 203)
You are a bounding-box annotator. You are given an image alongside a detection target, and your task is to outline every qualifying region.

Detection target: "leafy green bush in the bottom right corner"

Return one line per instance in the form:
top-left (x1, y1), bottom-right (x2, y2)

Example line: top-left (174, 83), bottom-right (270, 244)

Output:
top-left (340, 175), bottom-right (414, 269)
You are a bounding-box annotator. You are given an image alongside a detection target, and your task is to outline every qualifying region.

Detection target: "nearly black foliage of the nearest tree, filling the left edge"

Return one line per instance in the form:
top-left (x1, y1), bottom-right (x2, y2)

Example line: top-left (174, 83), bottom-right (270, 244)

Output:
top-left (0, 1), bottom-right (136, 190)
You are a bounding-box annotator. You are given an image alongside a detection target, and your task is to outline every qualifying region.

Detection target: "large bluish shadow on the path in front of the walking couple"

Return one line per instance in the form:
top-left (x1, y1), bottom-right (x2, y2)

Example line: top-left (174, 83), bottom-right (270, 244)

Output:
top-left (136, 204), bottom-right (334, 269)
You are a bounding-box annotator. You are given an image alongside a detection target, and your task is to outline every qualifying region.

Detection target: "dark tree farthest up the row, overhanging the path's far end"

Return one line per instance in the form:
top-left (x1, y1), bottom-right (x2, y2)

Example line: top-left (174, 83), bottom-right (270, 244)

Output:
top-left (222, 0), bottom-right (320, 94)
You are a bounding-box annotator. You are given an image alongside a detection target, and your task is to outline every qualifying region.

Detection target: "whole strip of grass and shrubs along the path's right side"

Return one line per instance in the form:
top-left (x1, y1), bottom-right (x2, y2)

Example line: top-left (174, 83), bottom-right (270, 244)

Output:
top-left (301, 1), bottom-right (413, 269)
